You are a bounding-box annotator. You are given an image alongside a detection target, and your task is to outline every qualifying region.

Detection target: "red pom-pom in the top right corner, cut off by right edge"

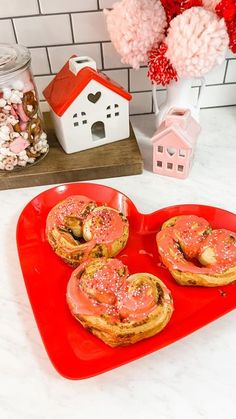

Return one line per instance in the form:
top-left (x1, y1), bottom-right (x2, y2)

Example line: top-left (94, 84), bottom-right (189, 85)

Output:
top-left (216, 0), bottom-right (236, 53)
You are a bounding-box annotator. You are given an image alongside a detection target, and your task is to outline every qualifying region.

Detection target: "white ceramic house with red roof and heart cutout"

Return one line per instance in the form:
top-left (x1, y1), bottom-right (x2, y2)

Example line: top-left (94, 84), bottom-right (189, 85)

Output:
top-left (43, 56), bottom-right (132, 153)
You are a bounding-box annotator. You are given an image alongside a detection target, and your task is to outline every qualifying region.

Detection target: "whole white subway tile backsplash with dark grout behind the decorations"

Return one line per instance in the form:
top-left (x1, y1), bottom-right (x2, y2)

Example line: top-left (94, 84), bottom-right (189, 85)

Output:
top-left (0, 0), bottom-right (236, 114)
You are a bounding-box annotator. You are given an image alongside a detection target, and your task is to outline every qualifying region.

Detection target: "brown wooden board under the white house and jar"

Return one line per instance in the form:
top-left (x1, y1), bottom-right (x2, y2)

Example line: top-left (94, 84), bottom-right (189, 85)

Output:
top-left (0, 113), bottom-right (143, 190)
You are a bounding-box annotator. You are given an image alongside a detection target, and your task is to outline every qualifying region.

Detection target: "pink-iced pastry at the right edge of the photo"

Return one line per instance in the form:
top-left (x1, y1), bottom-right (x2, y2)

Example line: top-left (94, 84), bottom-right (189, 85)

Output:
top-left (157, 215), bottom-right (236, 287)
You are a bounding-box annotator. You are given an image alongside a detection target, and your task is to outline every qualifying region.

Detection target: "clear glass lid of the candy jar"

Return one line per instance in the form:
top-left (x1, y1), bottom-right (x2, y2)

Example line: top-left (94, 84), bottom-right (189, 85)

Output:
top-left (0, 44), bottom-right (30, 76)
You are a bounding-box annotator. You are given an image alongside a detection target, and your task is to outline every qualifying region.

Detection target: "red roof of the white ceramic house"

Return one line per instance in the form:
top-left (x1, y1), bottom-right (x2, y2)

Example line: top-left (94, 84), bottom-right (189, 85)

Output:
top-left (43, 55), bottom-right (132, 116)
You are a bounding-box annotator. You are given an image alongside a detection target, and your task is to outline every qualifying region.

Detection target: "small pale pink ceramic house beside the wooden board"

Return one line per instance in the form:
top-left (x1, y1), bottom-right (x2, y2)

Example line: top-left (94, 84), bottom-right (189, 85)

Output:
top-left (152, 109), bottom-right (201, 179)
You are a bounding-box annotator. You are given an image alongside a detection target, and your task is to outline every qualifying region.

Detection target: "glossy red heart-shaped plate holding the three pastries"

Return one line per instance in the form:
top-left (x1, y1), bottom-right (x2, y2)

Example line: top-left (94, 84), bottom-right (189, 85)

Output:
top-left (17, 183), bottom-right (236, 379)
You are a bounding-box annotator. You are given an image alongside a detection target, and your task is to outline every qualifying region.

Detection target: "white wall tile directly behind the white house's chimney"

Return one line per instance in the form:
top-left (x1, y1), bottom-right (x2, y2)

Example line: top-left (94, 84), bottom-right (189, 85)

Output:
top-left (48, 44), bottom-right (102, 73)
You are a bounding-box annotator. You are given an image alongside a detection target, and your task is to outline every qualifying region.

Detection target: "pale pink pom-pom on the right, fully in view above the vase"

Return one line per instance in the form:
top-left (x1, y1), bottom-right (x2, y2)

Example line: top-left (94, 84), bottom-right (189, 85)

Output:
top-left (165, 7), bottom-right (229, 77)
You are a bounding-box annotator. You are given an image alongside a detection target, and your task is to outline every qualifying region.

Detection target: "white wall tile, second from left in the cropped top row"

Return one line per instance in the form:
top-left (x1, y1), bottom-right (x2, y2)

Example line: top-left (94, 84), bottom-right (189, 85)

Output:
top-left (39, 0), bottom-right (97, 13)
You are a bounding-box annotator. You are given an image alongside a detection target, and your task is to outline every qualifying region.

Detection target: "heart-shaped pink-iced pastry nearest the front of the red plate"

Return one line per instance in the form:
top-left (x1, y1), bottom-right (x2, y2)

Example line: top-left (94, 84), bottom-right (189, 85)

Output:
top-left (66, 258), bottom-right (173, 347)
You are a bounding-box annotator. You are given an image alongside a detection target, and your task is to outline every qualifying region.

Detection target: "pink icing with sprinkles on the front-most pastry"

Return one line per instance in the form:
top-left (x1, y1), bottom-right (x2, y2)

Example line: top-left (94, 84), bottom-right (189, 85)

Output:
top-left (67, 258), bottom-right (168, 322)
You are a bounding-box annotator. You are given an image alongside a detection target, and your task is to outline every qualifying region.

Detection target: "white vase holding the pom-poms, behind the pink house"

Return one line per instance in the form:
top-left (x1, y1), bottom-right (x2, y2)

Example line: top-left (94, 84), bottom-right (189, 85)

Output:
top-left (152, 77), bottom-right (205, 127)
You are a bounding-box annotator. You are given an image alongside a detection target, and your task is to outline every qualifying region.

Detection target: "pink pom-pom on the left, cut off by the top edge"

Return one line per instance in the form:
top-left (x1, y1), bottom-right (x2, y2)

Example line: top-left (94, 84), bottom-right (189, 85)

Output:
top-left (104, 0), bottom-right (167, 68)
